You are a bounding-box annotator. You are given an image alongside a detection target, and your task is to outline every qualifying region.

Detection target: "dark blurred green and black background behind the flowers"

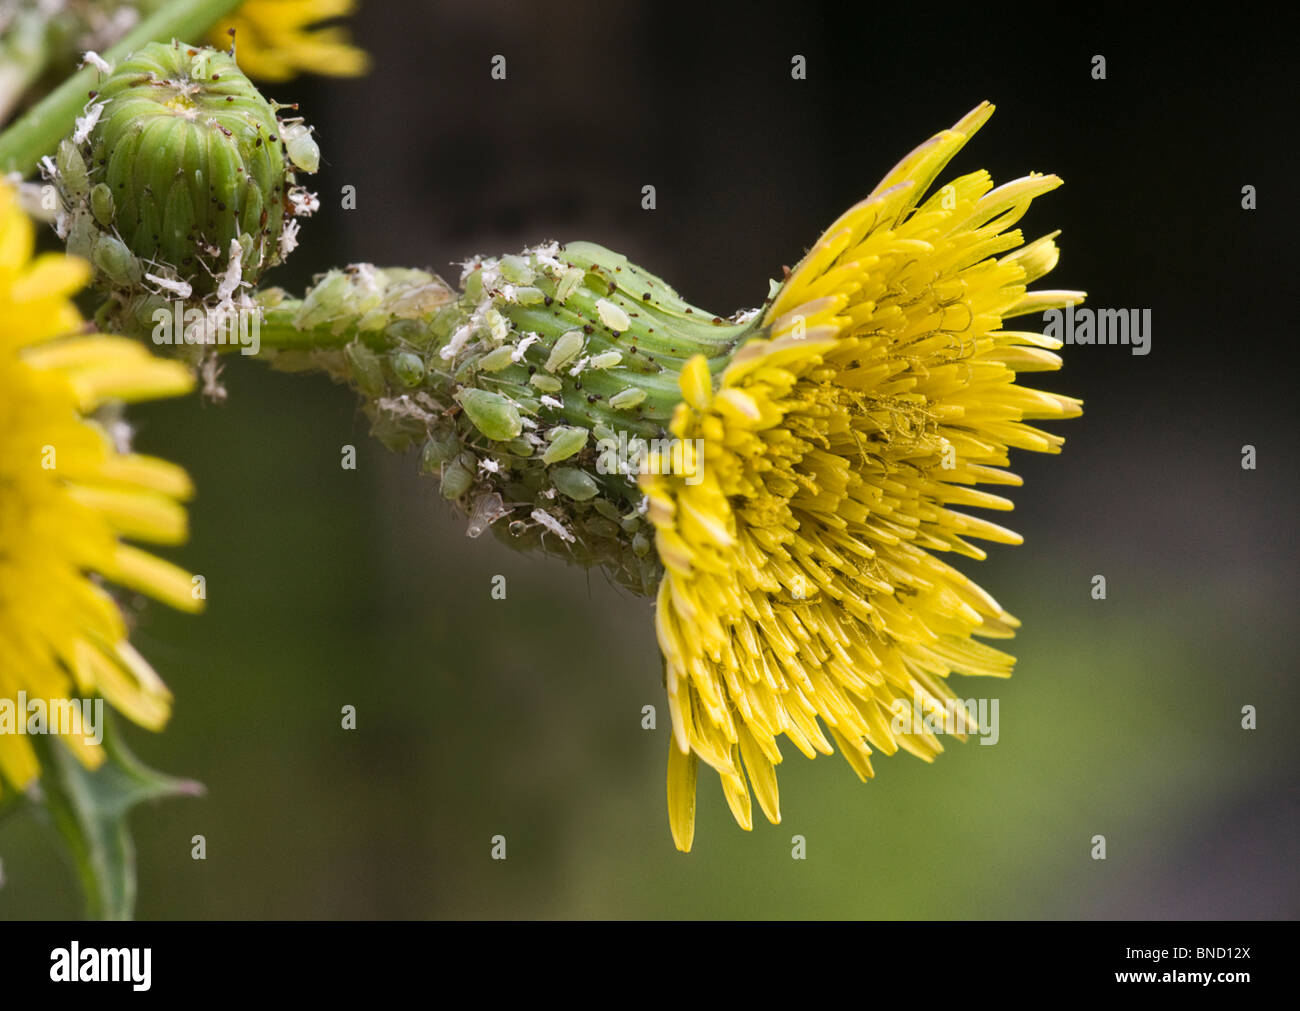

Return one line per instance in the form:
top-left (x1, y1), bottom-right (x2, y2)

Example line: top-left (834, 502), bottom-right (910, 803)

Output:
top-left (0, 0), bottom-right (1300, 919)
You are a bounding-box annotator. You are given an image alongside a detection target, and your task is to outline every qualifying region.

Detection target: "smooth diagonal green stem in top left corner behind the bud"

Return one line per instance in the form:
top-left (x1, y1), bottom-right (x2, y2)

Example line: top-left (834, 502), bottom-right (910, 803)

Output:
top-left (0, 0), bottom-right (242, 177)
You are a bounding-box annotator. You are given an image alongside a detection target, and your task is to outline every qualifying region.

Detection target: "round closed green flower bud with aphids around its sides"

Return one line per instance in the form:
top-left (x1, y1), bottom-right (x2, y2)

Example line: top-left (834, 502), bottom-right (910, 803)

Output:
top-left (46, 42), bottom-right (320, 330)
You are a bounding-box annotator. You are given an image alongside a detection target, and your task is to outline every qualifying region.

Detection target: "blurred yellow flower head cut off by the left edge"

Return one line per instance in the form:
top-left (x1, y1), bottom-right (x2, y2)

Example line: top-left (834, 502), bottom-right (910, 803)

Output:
top-left (0, 182), bottom-right (200, 789)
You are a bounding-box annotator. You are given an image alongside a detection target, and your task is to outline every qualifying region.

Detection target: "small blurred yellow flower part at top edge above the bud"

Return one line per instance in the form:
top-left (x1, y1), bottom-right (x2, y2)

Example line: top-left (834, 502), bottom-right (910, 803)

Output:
top-left (209, 0), bottom-right (371, 81)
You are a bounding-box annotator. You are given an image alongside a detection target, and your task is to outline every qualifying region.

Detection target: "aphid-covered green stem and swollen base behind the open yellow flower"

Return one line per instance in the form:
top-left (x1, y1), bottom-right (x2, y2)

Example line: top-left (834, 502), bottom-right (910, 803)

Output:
top-left (202, 252), bottom-right (766, 594)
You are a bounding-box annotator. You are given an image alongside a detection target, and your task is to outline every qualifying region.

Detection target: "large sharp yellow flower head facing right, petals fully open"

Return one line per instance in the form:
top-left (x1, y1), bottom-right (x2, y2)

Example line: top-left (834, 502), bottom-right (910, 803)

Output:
top-left (641, 103), bottom-right (1083, 850)
